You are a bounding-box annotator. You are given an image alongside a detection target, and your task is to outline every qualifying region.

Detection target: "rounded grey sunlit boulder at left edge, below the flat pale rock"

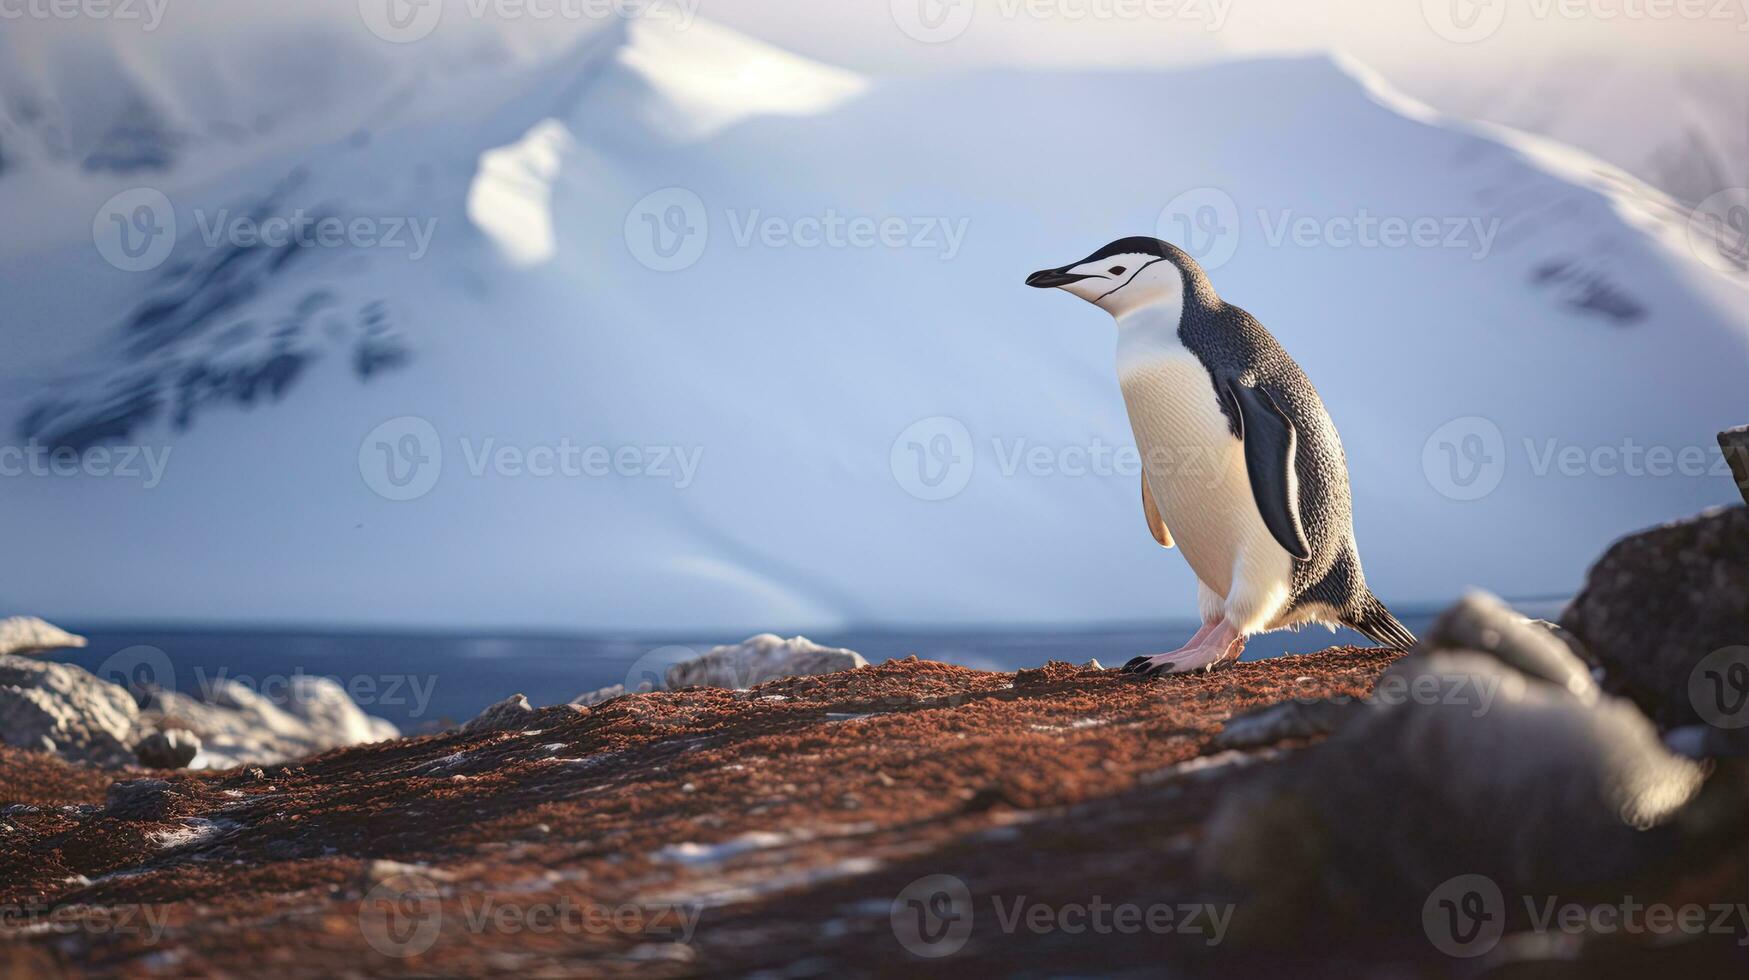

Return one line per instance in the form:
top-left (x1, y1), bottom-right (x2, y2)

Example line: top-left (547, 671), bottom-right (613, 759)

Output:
top-left (0, 656), bottom-right (140, 767)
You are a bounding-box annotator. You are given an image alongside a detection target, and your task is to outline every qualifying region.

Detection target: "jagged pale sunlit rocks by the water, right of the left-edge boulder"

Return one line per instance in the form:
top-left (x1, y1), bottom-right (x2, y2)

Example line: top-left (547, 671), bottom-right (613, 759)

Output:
top-left (140, 676), bottom-right (399, 768)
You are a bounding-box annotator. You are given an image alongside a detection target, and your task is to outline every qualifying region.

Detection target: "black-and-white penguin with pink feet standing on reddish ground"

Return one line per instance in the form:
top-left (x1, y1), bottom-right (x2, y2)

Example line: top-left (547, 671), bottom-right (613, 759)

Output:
top-left (1027, 238), bottom-right (1415, 676)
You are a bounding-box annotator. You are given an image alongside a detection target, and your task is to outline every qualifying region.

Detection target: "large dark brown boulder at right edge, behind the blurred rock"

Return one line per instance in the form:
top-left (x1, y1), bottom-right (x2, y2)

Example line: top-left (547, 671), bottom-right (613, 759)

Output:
top-left (1560, 508), bottom-right (1749, 728)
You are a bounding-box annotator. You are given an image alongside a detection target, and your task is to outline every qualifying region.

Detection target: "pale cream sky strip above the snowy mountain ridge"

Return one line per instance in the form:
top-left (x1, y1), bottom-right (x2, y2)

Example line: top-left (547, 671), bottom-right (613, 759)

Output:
top-left (17, 0), bottom-right (1749, 71)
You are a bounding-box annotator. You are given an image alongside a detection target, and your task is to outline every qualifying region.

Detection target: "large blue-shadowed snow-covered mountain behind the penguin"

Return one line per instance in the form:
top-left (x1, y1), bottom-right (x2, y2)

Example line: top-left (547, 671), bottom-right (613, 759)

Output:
top-left (0, 21), bottom-right (1749, 628)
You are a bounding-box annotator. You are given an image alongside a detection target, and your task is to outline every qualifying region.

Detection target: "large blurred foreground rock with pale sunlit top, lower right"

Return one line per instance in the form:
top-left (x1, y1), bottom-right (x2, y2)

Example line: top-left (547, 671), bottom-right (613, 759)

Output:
top-left (1202, 595), bottom-right (1705, 935)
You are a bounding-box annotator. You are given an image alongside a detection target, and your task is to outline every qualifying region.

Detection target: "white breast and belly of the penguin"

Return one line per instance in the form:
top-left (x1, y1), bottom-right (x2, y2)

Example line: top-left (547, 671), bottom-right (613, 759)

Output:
top-left (1118, 322), bottom-right (1293, 609)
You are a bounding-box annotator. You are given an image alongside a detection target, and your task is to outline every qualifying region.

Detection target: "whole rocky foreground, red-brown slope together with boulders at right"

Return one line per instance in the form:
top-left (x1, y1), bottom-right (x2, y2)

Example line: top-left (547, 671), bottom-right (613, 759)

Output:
top-left (0, 508), bottom-right (1749, 977)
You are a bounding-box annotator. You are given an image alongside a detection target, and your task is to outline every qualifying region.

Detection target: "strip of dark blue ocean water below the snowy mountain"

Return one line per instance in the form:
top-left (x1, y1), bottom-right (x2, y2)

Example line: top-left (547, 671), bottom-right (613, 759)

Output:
top-left (56, 602), bottom-right (1560, 732)
